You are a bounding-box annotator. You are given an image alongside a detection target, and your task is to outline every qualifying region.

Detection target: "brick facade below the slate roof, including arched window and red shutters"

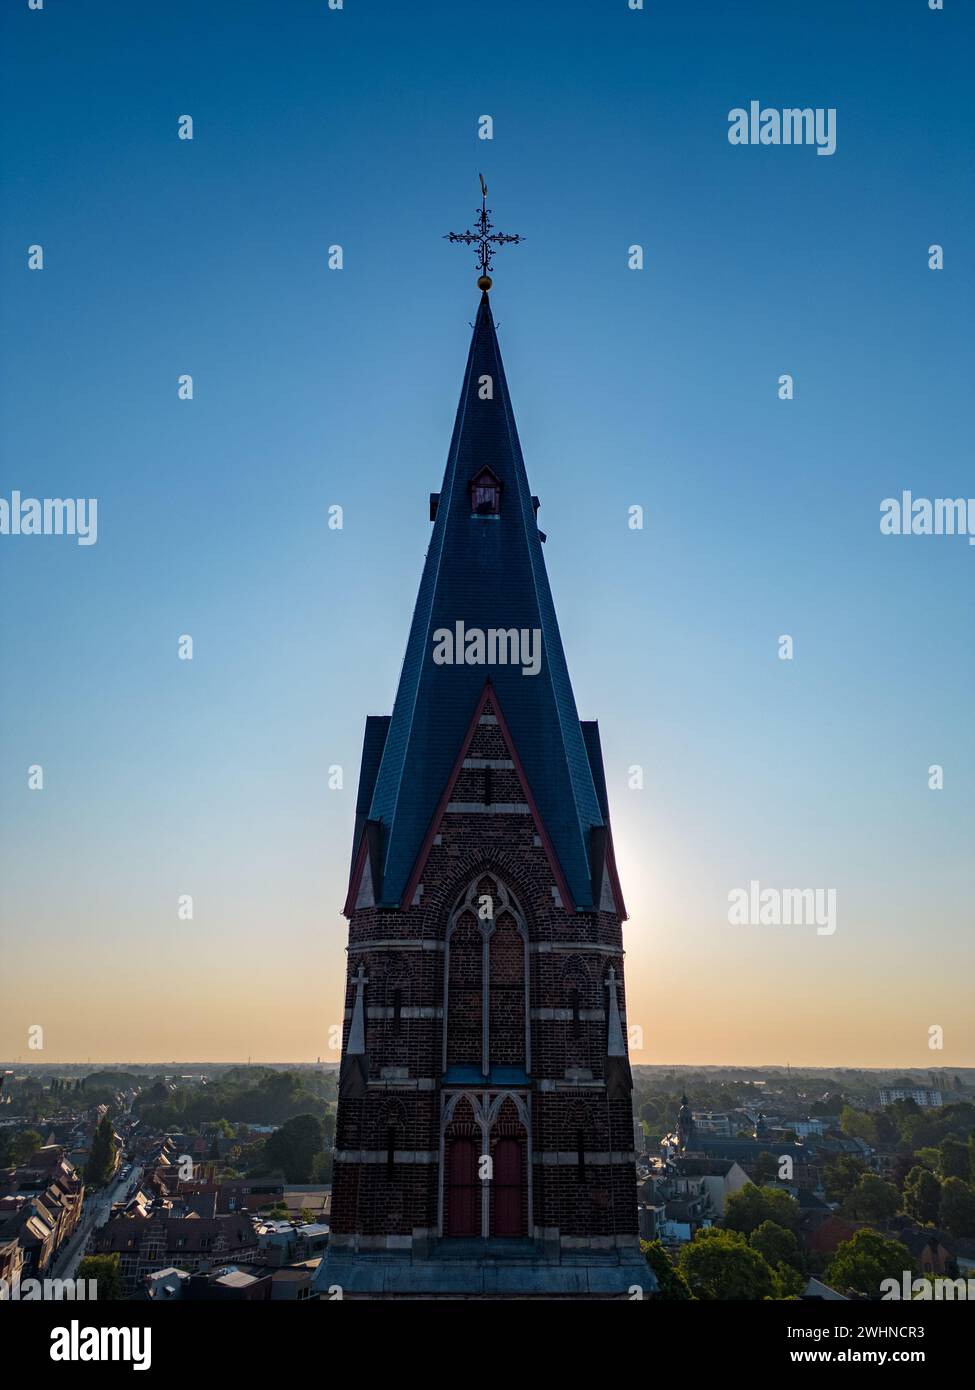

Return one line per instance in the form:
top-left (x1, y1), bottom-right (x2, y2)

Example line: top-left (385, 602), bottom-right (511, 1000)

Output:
top-left (331, 688), bottom-right (637, 1284)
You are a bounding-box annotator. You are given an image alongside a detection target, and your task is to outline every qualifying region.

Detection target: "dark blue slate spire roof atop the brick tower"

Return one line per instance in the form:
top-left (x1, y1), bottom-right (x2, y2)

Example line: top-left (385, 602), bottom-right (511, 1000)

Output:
top-left (353, 293), bottom-right (606, 909)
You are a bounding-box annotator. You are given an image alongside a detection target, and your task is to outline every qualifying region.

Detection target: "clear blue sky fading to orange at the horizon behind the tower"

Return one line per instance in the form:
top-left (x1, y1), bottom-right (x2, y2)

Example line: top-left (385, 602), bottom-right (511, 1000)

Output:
top-left (0, 0), bottom-right (975, 1066)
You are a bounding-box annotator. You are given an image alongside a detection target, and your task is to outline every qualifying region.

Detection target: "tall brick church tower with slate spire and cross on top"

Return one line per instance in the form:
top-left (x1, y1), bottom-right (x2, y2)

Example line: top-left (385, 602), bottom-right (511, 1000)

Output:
top-left (316, 190), bottom-right (654, 1298)
